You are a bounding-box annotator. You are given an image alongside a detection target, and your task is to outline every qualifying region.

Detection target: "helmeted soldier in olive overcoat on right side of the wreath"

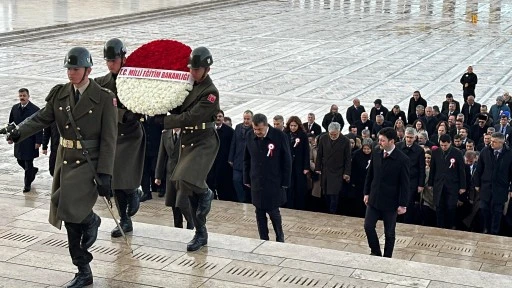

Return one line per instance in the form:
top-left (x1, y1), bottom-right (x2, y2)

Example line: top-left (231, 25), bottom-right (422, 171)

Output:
top-left (157, 47), bottom-right (220, 251)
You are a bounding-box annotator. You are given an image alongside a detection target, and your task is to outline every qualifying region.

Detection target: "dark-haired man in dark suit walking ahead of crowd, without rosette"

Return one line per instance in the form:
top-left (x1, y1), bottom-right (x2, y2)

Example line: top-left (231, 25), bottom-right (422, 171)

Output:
top-left (363, 127), bottom-right (410, 258)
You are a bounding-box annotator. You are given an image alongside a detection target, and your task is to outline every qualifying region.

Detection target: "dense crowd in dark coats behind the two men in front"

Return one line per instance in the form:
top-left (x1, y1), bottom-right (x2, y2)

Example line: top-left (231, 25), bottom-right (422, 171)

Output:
top-left (199, 67), bottom-right (512, 238)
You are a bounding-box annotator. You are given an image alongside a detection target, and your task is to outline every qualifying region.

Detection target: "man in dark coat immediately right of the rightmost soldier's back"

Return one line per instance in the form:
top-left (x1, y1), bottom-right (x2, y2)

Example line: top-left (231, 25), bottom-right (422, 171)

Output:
top-left (206, 110), bottom-right (237, 201)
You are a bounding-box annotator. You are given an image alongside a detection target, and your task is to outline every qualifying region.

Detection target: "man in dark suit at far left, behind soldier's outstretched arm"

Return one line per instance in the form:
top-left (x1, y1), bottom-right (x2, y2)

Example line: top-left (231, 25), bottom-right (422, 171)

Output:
top-left (9, 88), bottom-right (43, 192)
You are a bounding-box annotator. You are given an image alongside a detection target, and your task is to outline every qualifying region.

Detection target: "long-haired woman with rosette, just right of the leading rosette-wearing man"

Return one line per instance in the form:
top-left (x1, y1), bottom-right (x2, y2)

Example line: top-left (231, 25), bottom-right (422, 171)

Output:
top-left (284, 116), bottom-right (309, 210)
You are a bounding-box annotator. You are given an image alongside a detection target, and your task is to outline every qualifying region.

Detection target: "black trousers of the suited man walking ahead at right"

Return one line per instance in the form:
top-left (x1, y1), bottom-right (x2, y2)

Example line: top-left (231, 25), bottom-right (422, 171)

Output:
top-left (364, 206), bottom-right (397, 258)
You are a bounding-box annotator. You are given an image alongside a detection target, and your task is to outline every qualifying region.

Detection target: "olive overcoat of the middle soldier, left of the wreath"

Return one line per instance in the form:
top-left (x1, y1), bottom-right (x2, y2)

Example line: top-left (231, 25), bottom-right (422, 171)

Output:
top-left (94, 73), bottom-right (146, 190)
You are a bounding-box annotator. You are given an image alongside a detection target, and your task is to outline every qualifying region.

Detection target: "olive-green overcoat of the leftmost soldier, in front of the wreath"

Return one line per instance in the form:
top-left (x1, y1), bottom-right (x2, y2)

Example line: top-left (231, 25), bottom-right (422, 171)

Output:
top-left (19, 81), bottom-right (117, 229)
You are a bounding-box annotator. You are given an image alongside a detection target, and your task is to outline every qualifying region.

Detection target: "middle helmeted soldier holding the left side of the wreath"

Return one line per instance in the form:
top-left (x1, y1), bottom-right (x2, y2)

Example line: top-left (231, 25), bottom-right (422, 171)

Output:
top-left (94, 38), bottom-right (142, 238)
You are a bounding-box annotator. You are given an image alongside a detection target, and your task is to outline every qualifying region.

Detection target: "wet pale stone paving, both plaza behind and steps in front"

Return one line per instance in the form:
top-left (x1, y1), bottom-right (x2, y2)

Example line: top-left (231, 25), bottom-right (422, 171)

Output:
top-left (0, 0), bottom-right (512, 288)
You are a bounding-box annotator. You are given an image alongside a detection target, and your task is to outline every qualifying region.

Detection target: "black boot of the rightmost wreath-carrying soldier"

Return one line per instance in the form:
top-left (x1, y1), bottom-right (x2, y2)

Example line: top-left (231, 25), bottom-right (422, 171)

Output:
top-left (187, 189), bottom-right (213, 251)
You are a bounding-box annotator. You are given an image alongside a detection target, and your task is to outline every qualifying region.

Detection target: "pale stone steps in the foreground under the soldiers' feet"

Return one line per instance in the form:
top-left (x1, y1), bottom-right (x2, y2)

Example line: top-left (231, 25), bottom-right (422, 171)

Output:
top-left (0, 176), bottom-right (512, 288)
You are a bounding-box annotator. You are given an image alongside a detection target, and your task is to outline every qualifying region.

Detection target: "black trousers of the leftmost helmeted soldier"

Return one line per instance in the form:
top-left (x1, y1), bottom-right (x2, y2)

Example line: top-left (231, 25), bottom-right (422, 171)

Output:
top-left (64, 211), bottom-right (94, 267)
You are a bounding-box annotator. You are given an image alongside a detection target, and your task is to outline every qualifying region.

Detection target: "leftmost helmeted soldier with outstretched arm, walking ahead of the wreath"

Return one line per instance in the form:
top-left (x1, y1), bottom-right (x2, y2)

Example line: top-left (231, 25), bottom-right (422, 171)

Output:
top-left (8, 47), bottom-right (117, 288)
